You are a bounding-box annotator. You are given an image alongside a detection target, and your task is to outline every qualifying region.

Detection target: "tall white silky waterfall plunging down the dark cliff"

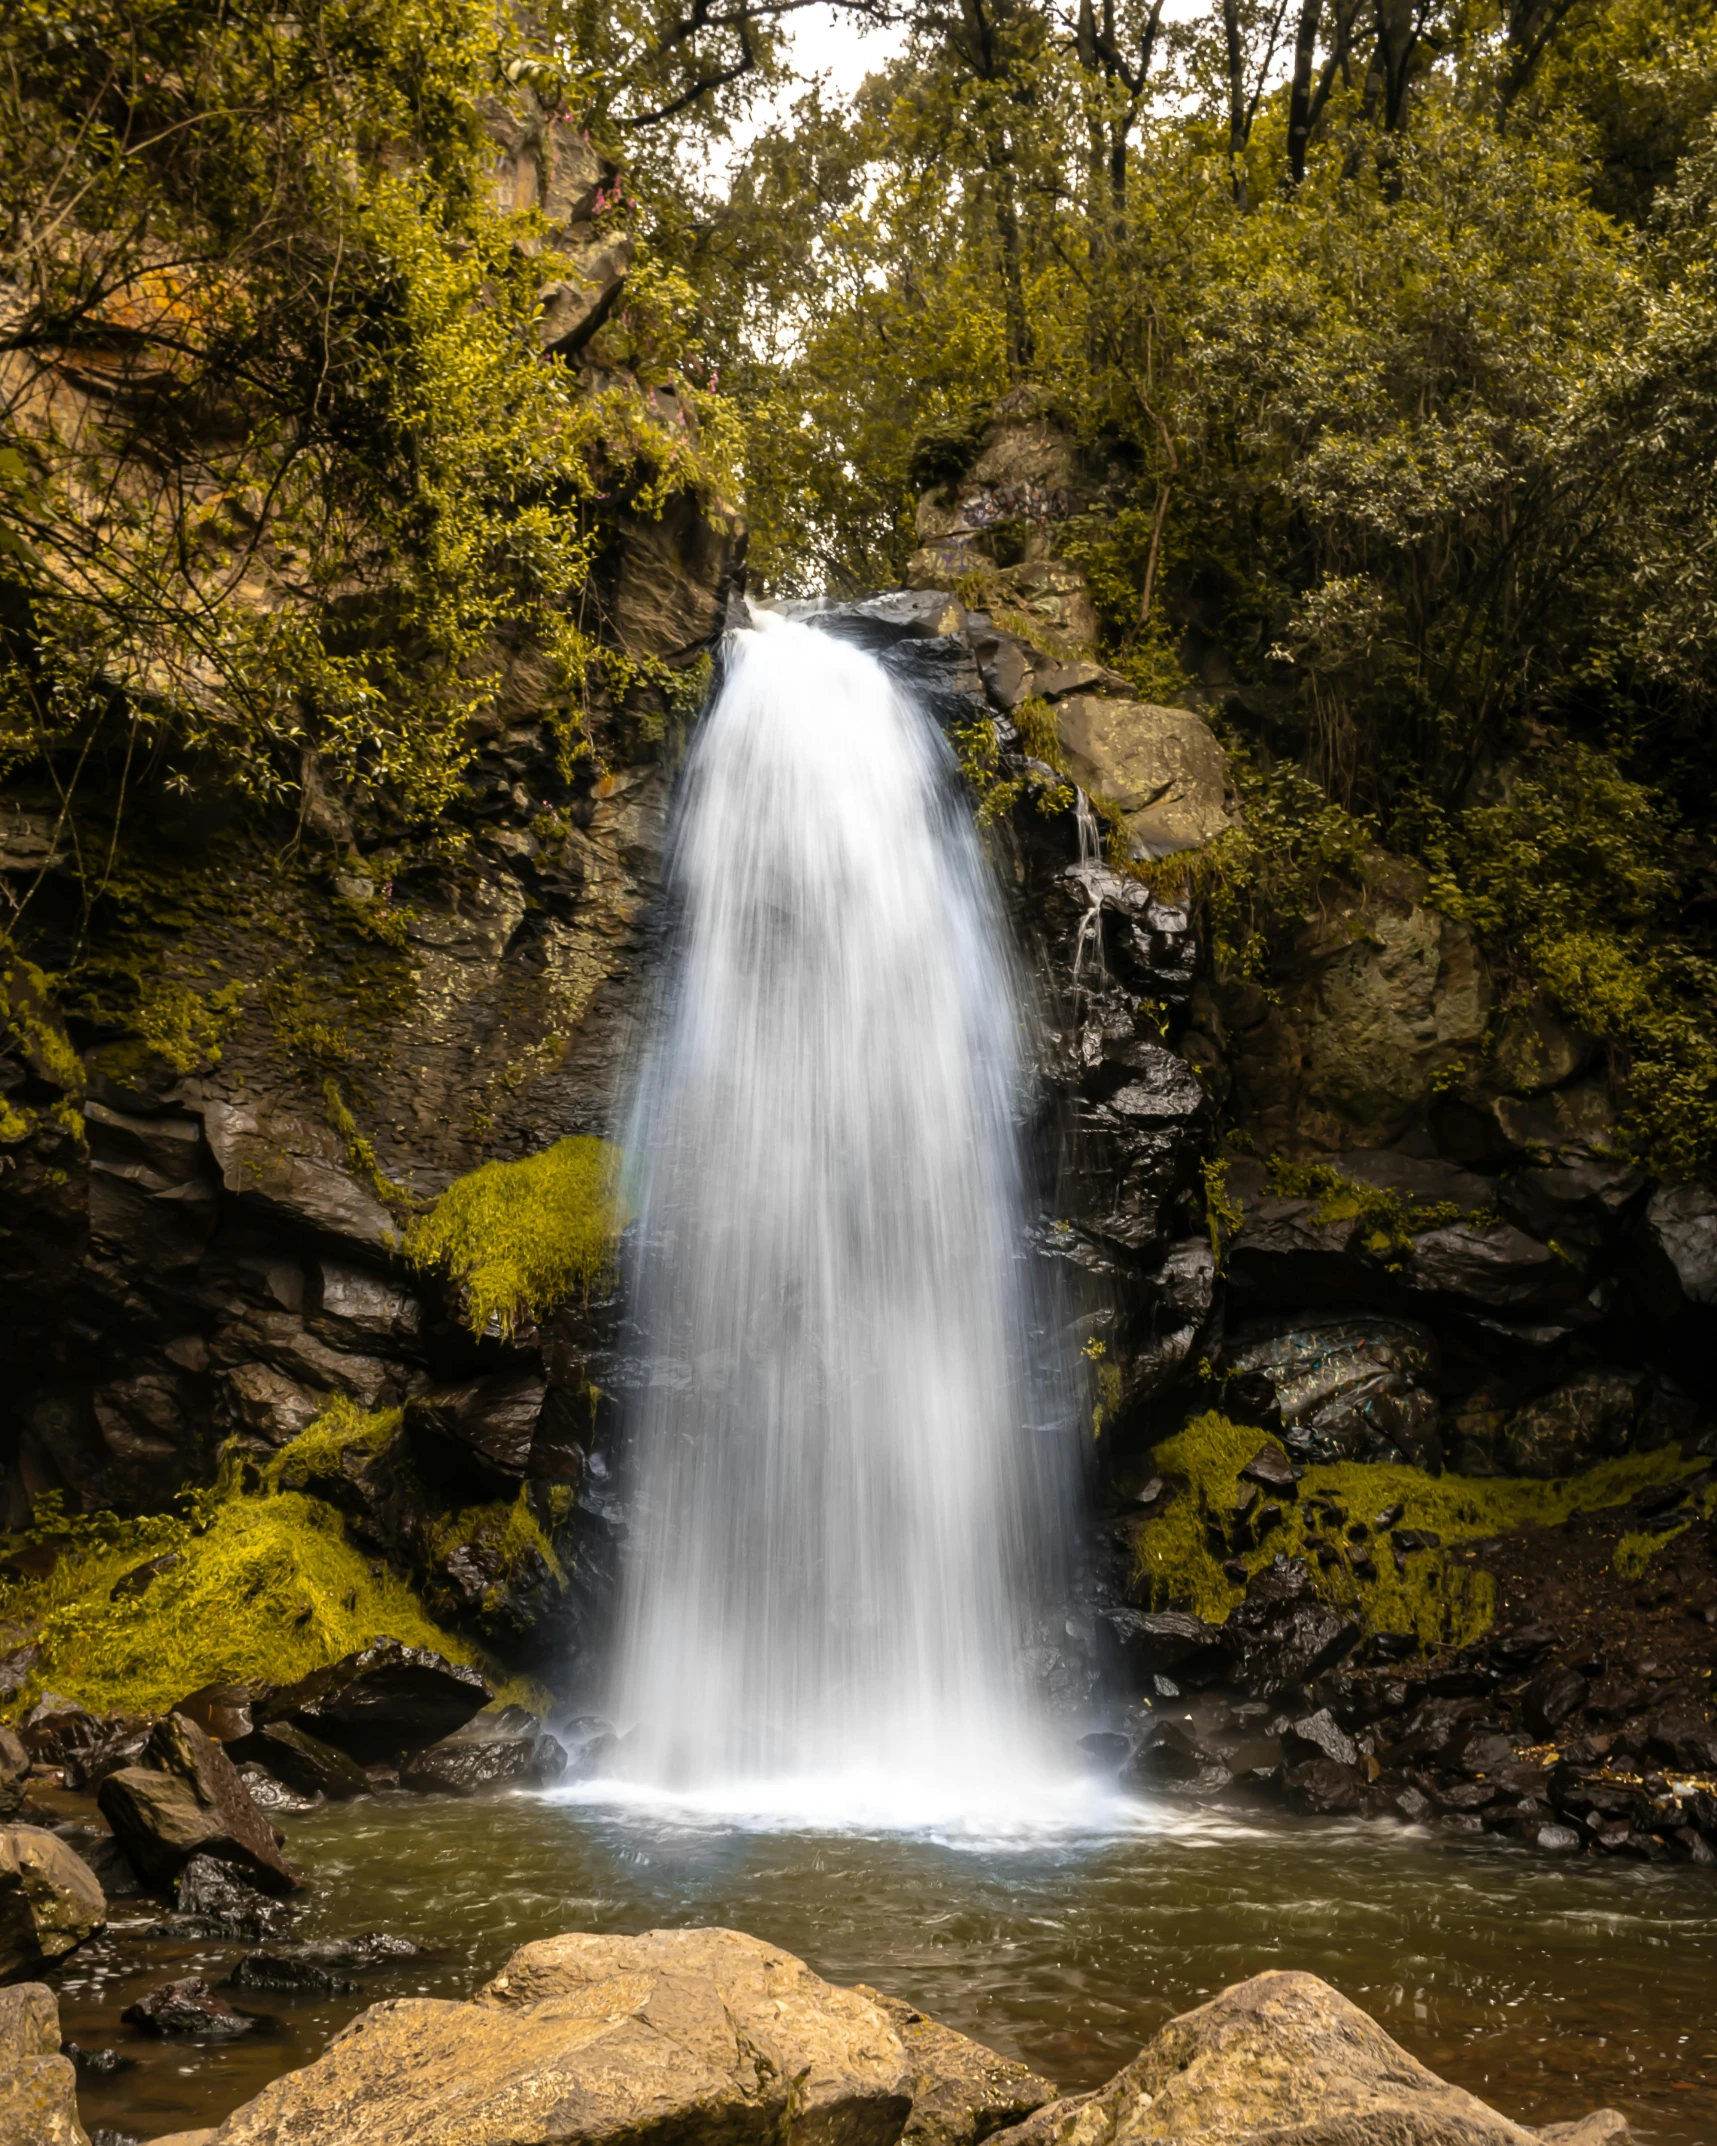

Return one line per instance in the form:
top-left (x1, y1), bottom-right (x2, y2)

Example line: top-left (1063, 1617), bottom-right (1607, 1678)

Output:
top-left (614, 616), bottom-right (1071, 1794)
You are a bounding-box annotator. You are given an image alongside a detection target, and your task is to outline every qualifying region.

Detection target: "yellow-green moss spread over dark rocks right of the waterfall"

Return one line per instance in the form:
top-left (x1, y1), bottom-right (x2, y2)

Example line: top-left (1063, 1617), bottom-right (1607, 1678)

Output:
top-left (1138, 1410), bottom-right (1702, 1646)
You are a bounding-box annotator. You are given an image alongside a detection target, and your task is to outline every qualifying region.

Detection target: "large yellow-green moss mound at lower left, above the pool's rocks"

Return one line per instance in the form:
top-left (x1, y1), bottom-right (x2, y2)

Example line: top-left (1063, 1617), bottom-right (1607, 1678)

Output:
top-left (0, 1485), bottom-right (476, 1713)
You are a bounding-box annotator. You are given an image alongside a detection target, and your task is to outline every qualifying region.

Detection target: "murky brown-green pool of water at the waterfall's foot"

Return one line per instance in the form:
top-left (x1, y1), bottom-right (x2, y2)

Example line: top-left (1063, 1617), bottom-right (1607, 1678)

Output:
top-left (60, 1790), bottom-right (1717, 2146)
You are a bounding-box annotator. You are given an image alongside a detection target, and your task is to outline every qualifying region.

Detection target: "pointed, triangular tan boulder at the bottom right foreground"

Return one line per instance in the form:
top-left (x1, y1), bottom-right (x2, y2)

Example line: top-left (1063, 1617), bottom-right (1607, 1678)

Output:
top-left (998, 1974), bottom-right (1535, 2146)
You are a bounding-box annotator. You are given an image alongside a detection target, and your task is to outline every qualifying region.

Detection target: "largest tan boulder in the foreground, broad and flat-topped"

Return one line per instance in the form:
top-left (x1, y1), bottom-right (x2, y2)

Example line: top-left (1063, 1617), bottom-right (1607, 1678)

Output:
top-left (197, 1929), bottom-right (914, 2146)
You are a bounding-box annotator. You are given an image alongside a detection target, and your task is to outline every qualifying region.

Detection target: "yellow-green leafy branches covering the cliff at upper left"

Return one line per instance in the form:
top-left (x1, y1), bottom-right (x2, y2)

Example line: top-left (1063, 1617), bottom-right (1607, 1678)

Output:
top-left (0, 0), bottom-right (721, 869)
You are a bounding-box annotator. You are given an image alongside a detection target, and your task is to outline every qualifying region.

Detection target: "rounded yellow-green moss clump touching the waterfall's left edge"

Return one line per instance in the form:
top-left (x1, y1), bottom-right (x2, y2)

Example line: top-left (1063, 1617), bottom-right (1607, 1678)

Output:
top-left (403, 1140), bottom-right (625, 1333)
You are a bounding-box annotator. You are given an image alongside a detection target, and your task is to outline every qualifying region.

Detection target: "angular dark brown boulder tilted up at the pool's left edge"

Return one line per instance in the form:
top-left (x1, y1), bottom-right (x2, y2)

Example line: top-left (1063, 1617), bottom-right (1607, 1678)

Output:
top-left (97, 1715), bottom-right (303, 1893)
